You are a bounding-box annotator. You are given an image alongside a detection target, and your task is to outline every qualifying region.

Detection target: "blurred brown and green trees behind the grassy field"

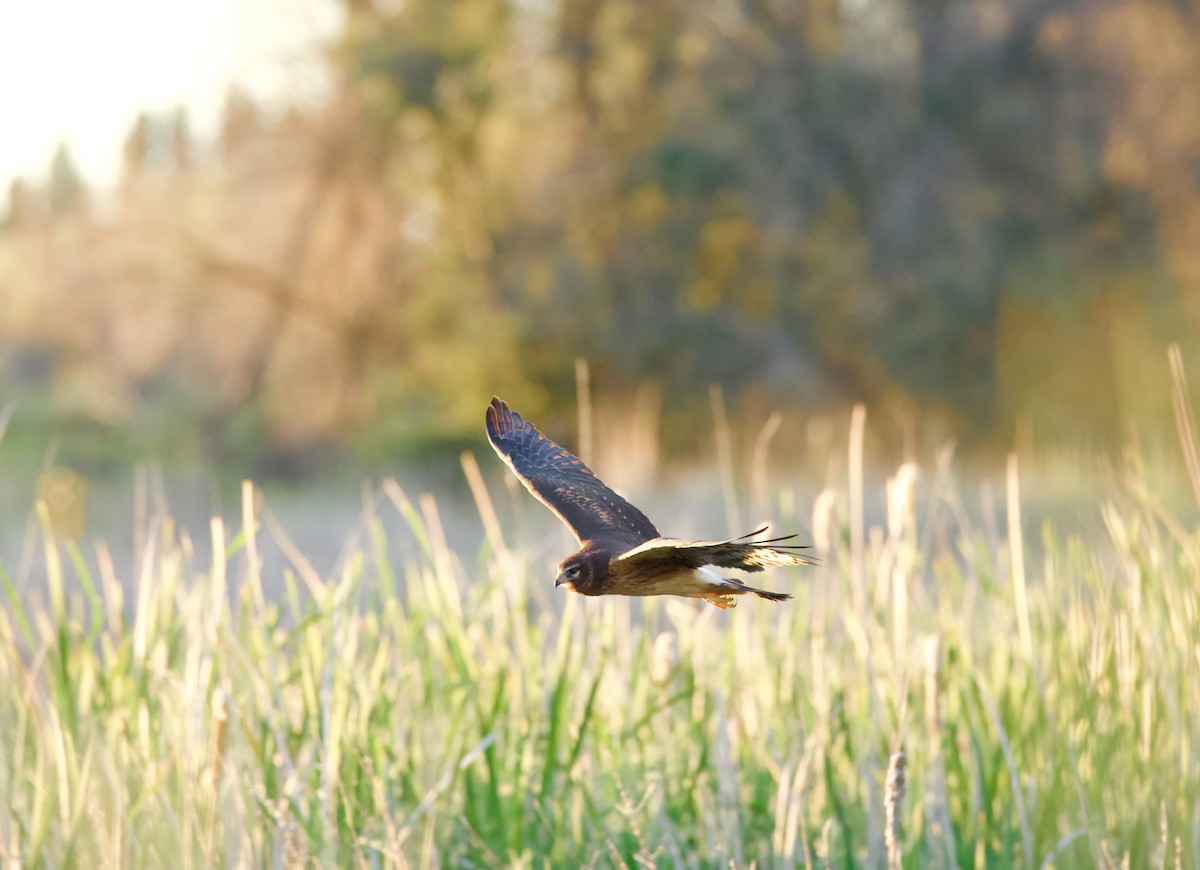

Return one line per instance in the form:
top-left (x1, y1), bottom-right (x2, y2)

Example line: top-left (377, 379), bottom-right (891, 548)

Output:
top-left (0, 0), bottom-right (1200, 479)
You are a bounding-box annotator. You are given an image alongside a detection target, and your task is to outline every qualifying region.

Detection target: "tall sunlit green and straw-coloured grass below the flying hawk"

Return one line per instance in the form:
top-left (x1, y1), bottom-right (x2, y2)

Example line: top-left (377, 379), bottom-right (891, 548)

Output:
top-left (0, 398), bottom-right (1200, 868)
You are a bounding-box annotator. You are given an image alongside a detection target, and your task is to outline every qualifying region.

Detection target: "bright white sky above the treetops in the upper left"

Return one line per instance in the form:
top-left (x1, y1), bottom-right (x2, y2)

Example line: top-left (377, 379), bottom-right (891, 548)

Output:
top-left (0, 0), bottom-right (340, 189)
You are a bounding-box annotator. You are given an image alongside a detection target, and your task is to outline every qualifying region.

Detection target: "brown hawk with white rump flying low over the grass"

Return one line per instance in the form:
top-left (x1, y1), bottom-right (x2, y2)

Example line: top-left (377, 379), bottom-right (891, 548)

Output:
top-left (487, 397), bottom-right (814, 607)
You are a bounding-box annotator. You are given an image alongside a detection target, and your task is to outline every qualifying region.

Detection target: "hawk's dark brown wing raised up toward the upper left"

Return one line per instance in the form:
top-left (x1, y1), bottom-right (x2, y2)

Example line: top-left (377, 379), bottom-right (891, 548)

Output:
top-left (487, 397), bottom-right (659, 546)
